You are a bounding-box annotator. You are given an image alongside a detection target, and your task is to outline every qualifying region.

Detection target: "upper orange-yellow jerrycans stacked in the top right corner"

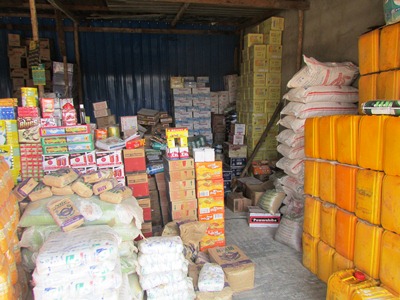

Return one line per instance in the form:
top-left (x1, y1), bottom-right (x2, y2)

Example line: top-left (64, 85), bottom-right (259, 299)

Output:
top-left (358, 23), bottom-right (400, 113)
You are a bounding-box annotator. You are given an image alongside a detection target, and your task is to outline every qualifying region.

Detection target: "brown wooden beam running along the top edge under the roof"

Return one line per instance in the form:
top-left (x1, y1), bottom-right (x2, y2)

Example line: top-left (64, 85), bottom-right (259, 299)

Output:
top-left (149, 0), bottom-right (310, 10)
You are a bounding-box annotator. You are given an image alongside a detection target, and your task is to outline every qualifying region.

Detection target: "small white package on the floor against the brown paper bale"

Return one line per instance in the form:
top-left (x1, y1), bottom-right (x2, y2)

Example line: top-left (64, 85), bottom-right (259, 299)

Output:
top-left (198, 263), bottom-right (225, 292)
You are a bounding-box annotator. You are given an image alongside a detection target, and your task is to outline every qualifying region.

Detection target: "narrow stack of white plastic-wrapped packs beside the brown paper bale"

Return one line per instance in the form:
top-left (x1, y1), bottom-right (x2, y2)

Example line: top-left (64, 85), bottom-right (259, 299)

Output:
top-left (137, 236), bottom-right (196, 300)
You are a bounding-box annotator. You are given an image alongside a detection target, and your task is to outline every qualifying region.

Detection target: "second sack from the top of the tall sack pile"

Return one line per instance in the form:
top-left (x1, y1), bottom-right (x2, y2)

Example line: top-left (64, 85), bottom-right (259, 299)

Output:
top-left (283, 85), bottom-right (358, 103)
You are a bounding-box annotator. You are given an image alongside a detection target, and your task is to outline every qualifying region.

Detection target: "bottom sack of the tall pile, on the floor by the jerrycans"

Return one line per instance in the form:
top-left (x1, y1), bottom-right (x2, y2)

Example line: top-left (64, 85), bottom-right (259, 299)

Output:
top-left (274, 215), bottom-right (303, 251)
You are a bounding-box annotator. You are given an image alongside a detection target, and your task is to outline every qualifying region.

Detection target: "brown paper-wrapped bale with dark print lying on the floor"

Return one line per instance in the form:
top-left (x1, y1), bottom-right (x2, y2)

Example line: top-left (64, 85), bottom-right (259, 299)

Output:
top-left (208, 245), bottom-right (255, 292)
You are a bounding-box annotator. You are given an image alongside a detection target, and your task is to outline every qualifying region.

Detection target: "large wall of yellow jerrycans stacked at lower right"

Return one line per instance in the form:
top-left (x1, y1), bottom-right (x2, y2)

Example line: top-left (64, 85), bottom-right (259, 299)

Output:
top-left (303, 115), bottom-right (400, 299)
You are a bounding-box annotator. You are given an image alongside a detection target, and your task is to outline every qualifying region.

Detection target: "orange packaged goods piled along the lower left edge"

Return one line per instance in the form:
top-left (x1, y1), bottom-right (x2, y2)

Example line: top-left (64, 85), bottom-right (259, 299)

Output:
top-left (0, 157), bottom-right (28, 299)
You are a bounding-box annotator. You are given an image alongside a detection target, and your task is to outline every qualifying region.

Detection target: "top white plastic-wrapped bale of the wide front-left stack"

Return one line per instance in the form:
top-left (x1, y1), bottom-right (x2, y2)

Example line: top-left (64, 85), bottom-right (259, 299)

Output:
top-left (36, 225), bottom-right (121, 274)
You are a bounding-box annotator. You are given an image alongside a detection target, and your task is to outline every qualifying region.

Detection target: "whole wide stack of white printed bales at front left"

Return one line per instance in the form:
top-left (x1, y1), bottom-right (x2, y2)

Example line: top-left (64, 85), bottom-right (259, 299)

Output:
top-left (33, 225), bottom-right (122, 300)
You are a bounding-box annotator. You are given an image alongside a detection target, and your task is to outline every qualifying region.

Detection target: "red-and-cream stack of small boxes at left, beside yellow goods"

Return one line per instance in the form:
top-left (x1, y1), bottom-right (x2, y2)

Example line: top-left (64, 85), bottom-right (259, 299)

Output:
top-left (17, 107), bottom-right (43, 181)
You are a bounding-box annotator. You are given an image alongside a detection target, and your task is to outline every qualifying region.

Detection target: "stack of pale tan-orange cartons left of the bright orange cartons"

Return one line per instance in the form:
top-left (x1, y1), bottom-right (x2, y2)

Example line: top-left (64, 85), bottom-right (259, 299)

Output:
top-left (163, 157), bottom-right (197, 221)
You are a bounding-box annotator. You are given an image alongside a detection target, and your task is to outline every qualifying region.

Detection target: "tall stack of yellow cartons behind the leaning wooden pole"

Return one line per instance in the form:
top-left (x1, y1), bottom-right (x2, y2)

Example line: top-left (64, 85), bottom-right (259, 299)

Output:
top-left (237, 17), bottom-right (284, 160)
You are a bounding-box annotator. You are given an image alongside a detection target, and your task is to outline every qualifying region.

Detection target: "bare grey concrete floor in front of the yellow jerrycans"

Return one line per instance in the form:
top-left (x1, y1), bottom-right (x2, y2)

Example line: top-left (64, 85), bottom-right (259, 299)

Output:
top-left (225, 208), bottom-right (326, 300)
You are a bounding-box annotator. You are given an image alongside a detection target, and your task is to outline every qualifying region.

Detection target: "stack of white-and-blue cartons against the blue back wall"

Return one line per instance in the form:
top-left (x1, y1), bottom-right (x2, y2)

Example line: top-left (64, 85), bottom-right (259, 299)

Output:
top-left (172, 81), bottom-right (213, 144)
